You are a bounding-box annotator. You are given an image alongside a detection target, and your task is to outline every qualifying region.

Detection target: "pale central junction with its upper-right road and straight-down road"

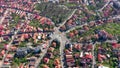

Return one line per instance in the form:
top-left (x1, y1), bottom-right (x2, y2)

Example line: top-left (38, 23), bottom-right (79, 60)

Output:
top-left (52, 9), bottom-right (77, 68)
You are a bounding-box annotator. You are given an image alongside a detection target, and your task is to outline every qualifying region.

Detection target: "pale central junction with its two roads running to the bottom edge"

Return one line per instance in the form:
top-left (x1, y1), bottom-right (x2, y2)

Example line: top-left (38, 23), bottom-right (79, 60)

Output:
top-left (35, 27), bottom-right (68, 68)
